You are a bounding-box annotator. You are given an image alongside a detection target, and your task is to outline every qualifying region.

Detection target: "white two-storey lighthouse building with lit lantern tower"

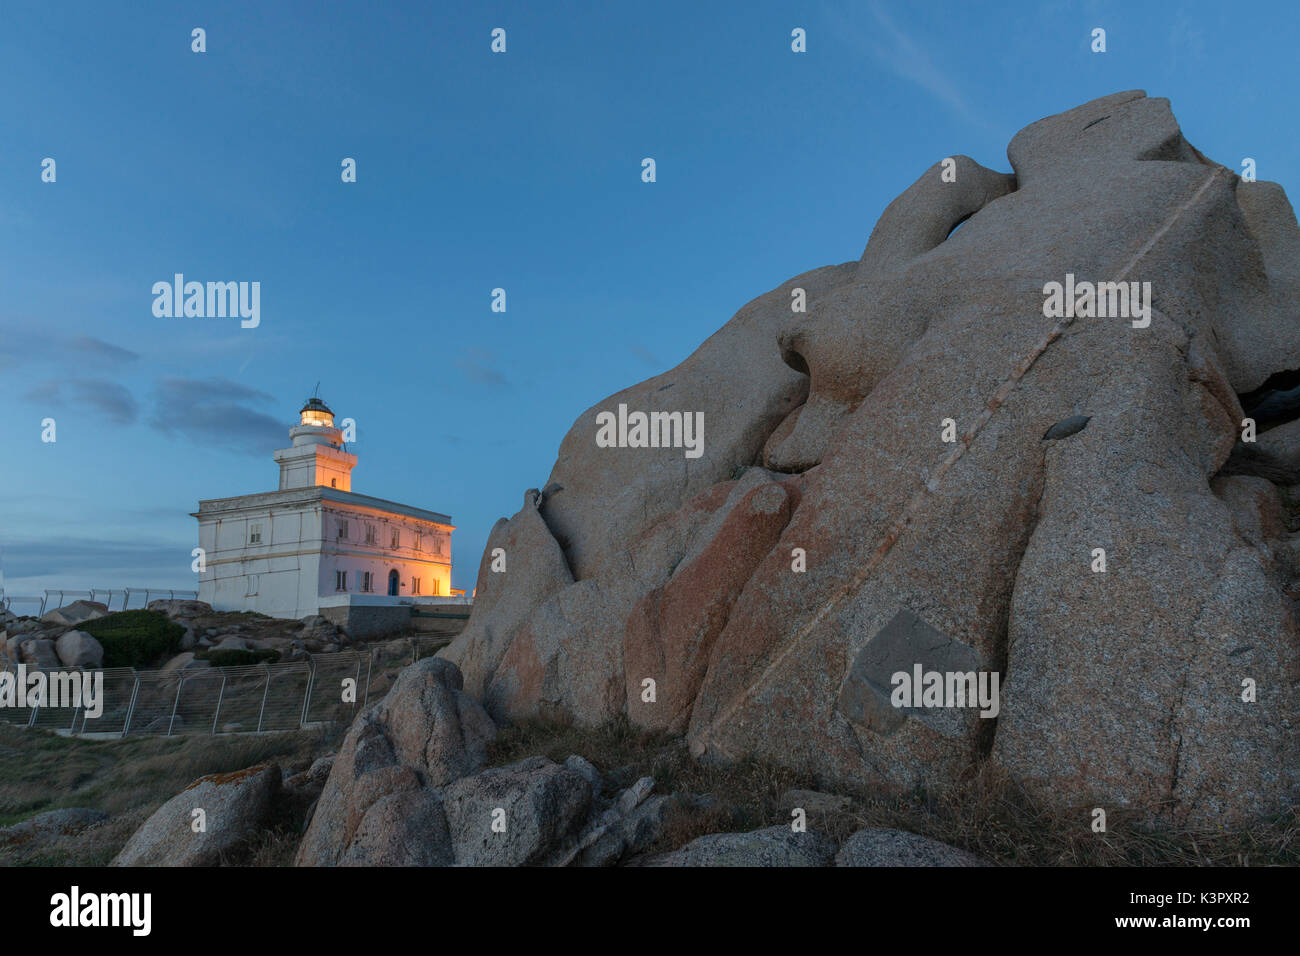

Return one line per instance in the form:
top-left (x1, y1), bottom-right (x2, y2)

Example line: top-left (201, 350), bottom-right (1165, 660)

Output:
top-left (194, 398), bottom-right (454, 633)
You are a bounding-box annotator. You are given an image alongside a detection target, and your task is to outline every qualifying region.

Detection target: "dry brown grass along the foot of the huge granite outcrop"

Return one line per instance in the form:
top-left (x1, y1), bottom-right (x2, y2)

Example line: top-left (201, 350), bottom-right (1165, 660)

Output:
top-left (490, 719), bottom-right (1300, 866)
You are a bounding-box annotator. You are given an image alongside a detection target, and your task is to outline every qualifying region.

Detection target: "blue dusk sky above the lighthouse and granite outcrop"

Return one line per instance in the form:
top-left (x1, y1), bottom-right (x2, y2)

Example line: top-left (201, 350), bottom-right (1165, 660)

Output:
top-left (0, 0), bottom-right (1300, 594)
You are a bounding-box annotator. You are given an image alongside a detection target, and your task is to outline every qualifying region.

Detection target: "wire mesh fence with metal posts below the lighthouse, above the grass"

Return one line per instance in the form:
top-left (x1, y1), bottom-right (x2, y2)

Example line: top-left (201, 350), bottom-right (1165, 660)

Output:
top-left (0, 637), bottom-right (447, 737)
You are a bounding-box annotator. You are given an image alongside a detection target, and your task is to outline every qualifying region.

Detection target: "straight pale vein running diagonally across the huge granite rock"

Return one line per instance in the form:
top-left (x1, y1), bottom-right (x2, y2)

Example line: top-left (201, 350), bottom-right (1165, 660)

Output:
top-left (699, 166), bottom-right (1225, 756)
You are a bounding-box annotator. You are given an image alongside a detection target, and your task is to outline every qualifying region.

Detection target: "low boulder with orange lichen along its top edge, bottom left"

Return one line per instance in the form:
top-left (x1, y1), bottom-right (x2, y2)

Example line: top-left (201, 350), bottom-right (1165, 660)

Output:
top-left (113, 763), bottom-right (281, 866)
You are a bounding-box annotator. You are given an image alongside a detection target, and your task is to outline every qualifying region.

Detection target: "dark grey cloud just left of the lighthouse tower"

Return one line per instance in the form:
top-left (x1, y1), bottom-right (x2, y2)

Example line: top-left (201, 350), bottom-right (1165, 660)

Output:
top-left (150, 376), bottom-right (287, 455)
